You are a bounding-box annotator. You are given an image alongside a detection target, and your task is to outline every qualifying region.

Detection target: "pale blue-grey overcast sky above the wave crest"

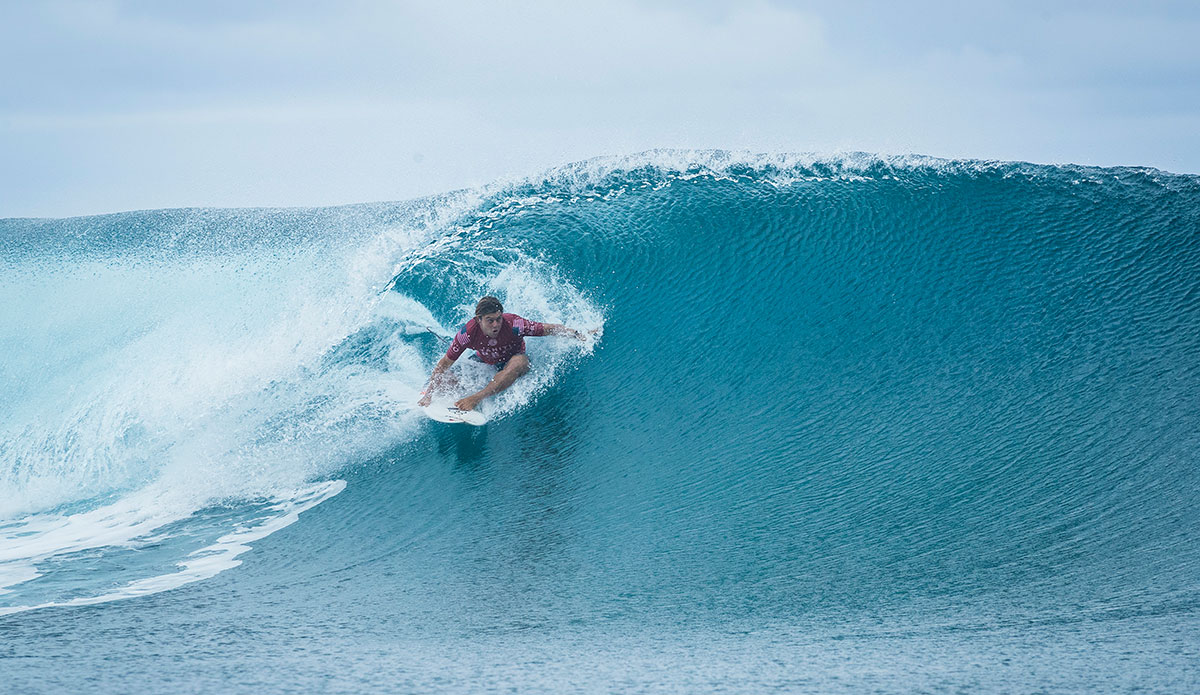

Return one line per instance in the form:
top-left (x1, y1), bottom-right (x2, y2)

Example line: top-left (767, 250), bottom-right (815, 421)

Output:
top-left (0, 0), bottom-right (1200, 217)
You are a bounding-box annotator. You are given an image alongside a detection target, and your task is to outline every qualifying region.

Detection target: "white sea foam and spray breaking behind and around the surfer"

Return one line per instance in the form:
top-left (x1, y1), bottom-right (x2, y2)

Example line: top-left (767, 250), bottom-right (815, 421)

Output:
top-left (0, 181), bottom-right (602, 612)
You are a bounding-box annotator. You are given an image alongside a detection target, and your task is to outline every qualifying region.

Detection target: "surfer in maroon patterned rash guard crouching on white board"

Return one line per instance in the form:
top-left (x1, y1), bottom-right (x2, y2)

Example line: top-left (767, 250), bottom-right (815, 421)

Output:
top-left (418, 296), bottom-right (598, 411)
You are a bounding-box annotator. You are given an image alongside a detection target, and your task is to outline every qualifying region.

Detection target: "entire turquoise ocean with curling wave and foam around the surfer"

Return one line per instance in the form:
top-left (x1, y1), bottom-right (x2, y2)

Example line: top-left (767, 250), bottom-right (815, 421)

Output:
top-left (0, 151), bottom-right (1200, 694)
